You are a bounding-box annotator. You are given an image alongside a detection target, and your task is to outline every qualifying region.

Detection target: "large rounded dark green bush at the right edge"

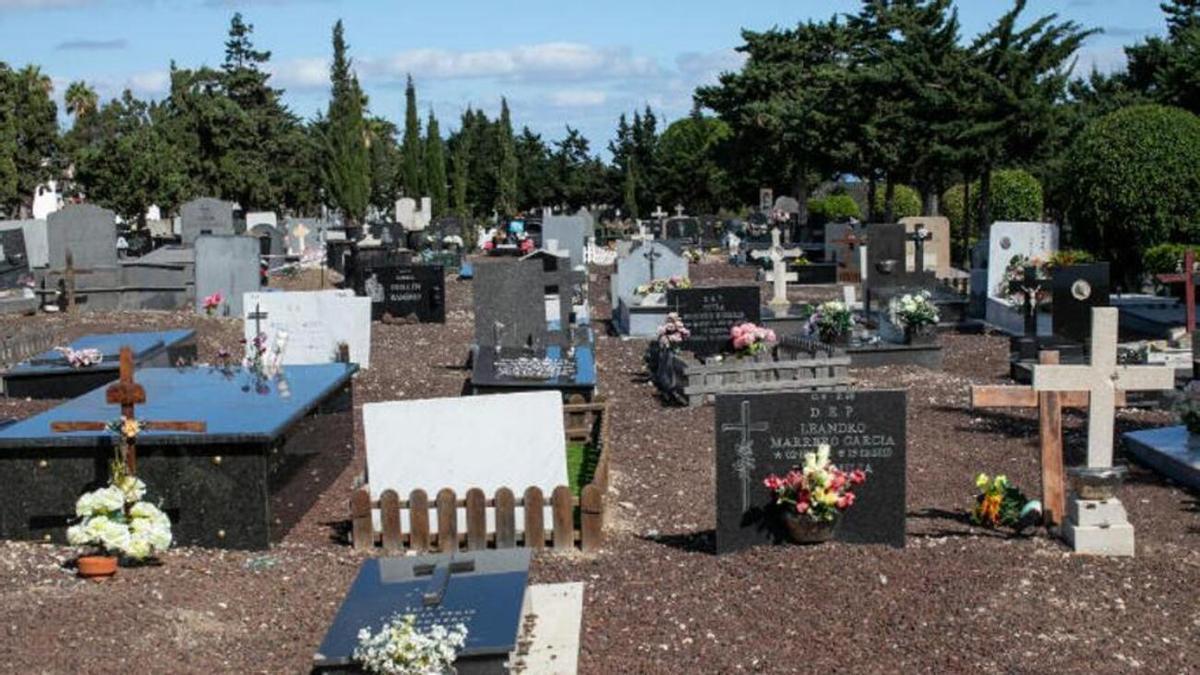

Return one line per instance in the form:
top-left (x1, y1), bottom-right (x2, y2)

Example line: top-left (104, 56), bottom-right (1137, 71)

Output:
top-left (1066, 106), bottom-right (1200, 281)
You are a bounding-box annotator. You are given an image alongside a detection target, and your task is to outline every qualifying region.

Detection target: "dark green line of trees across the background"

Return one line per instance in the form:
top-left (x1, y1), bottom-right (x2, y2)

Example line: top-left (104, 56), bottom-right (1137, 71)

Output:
top-left (0, 0), bottom-right (1200, 254)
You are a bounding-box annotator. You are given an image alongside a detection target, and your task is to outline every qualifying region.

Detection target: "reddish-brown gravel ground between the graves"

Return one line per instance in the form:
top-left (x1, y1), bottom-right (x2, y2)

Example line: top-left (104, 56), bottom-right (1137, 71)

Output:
top-left (0, 264), bottom-right (1200, 673)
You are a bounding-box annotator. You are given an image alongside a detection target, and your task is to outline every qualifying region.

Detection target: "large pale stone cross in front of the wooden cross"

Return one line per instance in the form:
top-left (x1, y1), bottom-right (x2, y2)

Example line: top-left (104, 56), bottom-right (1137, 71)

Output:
top-left (1033, 307), bottom-right (1175, 468)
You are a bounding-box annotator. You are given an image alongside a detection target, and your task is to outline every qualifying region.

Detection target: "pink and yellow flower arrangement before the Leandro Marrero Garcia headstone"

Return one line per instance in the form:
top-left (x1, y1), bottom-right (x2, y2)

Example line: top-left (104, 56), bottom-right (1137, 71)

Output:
top-left (762, 446), bottom-right (866, 521)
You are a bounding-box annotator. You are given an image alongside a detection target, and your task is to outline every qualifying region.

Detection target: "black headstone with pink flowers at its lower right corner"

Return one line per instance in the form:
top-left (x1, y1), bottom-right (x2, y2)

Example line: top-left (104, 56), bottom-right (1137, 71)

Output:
top-left (667, 286), bottom-right (762, 357)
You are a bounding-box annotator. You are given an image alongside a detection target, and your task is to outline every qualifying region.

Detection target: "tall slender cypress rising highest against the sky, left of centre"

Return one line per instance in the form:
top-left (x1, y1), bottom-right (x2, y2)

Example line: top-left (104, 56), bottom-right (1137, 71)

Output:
top-left (325, 19), bottom-right (371, 227)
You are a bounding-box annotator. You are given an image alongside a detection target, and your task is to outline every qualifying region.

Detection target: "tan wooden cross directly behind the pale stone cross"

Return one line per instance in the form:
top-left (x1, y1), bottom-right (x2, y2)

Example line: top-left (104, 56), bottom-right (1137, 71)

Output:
top-left (971, 352), bottom-right (1126, 527)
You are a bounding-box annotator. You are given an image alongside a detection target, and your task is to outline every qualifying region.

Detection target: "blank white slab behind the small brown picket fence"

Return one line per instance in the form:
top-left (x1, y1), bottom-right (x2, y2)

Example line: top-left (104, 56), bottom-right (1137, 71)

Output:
top-left (362, 392), bottom-right (569, 532)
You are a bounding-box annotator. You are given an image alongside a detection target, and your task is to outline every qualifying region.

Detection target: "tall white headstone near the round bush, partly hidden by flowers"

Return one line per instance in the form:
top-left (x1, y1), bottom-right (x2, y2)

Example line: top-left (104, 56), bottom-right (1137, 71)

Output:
top-left (986, 221), bottom-right (1058, 335)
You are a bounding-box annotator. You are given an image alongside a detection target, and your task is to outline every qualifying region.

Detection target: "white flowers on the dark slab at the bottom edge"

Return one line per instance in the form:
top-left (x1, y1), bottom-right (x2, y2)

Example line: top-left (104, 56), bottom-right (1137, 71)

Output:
top-left (354, 614), bottom-right (467, 675)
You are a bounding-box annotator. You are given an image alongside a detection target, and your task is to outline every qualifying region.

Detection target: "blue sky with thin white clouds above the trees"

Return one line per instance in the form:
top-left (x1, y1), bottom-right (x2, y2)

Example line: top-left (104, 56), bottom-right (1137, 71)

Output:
top-left (0, 0), bottom-right (1163, 150)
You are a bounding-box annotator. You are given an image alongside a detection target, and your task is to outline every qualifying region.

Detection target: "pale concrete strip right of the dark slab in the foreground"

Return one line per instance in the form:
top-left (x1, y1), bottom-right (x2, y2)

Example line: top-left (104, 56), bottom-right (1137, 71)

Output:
top-left (510, 583), bottom-right (583, 675)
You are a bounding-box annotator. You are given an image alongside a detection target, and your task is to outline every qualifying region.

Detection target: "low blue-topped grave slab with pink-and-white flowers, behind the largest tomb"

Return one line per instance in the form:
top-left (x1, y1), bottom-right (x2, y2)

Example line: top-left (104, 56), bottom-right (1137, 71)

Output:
top-left (4, 329), bottom-right (196, 399)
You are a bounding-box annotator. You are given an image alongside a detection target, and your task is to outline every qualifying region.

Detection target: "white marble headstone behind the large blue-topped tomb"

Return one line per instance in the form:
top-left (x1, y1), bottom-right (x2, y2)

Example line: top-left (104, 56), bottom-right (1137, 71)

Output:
top-left (242, 285), bottom-right (371, 370)
